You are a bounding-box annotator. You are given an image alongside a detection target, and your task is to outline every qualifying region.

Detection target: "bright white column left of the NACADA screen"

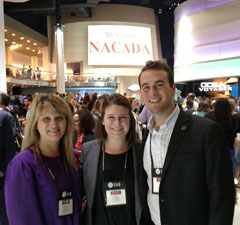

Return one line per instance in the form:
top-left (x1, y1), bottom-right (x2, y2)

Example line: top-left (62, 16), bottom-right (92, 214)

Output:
top-left (55, 25), bottom-right (65, 93)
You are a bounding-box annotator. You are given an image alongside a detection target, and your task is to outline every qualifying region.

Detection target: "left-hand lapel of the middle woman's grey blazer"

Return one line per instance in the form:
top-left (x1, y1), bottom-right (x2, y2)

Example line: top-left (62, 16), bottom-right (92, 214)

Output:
top-left (86, 142), bottom-right (101, 210)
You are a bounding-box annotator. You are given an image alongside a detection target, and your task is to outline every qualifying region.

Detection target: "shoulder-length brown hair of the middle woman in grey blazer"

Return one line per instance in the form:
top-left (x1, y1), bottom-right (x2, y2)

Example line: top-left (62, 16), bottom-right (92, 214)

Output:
top-left (95, 94), bottom-right (137, 147)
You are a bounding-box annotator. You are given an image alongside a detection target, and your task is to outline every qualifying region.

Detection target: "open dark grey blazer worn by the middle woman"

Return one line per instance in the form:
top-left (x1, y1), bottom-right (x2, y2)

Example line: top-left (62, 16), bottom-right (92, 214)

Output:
top-left (82, 140), bottom-right (153, 225)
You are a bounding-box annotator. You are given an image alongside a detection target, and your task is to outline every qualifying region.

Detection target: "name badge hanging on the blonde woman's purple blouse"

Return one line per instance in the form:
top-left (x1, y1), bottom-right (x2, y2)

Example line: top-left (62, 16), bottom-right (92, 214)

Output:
top-left (58, 191), bottom-right (73, 217)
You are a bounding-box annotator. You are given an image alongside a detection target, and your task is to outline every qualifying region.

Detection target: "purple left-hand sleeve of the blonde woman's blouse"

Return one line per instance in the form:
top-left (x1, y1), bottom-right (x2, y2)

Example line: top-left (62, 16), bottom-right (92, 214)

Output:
top-left (5, 155), bottom-right (46, 225)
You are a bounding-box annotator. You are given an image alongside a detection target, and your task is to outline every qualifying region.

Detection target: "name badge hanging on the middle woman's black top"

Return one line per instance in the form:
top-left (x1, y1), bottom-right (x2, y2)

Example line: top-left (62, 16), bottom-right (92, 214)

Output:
top-left (104, 181), bottom-right (127, 207)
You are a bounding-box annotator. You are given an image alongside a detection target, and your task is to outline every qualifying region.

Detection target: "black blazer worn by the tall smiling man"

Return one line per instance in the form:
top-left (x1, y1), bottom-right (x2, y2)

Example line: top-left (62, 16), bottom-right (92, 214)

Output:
top-left (143, 110), bottom-right (235, 225)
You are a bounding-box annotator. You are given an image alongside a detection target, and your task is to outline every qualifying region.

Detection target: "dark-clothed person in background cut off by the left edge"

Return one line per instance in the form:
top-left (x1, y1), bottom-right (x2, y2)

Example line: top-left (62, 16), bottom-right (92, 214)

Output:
top-left (0, 93), bottom-right (16, 225)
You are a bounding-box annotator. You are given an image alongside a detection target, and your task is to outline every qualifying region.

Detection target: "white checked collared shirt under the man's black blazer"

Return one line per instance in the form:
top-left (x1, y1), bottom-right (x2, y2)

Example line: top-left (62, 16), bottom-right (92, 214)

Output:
top-left (143, 105), bottom-right (180, 225)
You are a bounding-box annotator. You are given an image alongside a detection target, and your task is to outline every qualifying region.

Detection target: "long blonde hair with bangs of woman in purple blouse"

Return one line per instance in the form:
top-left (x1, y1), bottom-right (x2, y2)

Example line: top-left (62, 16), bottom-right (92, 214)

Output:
top-left (21, 93), bottom-right (77, 170)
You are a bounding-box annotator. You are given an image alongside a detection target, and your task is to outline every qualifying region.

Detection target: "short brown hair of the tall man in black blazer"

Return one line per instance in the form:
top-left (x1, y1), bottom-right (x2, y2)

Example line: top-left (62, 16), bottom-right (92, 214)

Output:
top-left (138, 60), bottom-right (174, 88)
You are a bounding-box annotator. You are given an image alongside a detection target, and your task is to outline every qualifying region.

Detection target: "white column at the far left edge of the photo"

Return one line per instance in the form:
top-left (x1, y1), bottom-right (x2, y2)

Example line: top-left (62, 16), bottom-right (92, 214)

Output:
top-left (0, 0), bottom-right (7, 93)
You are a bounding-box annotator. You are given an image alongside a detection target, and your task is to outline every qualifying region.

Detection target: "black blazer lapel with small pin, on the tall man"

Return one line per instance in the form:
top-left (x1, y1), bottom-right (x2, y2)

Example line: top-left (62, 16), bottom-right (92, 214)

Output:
top-left (161, 110), bottom-right (192, 183)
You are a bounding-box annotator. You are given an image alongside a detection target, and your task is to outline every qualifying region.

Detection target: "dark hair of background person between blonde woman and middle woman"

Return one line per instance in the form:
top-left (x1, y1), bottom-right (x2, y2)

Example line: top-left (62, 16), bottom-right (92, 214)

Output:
top-left (74, 109), bottom-right (95, 132)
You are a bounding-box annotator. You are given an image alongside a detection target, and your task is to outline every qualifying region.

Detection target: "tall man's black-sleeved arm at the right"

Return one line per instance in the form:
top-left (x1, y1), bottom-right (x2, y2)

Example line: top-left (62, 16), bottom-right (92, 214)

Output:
top-left (205, 123), bottom-right (235, 225)
